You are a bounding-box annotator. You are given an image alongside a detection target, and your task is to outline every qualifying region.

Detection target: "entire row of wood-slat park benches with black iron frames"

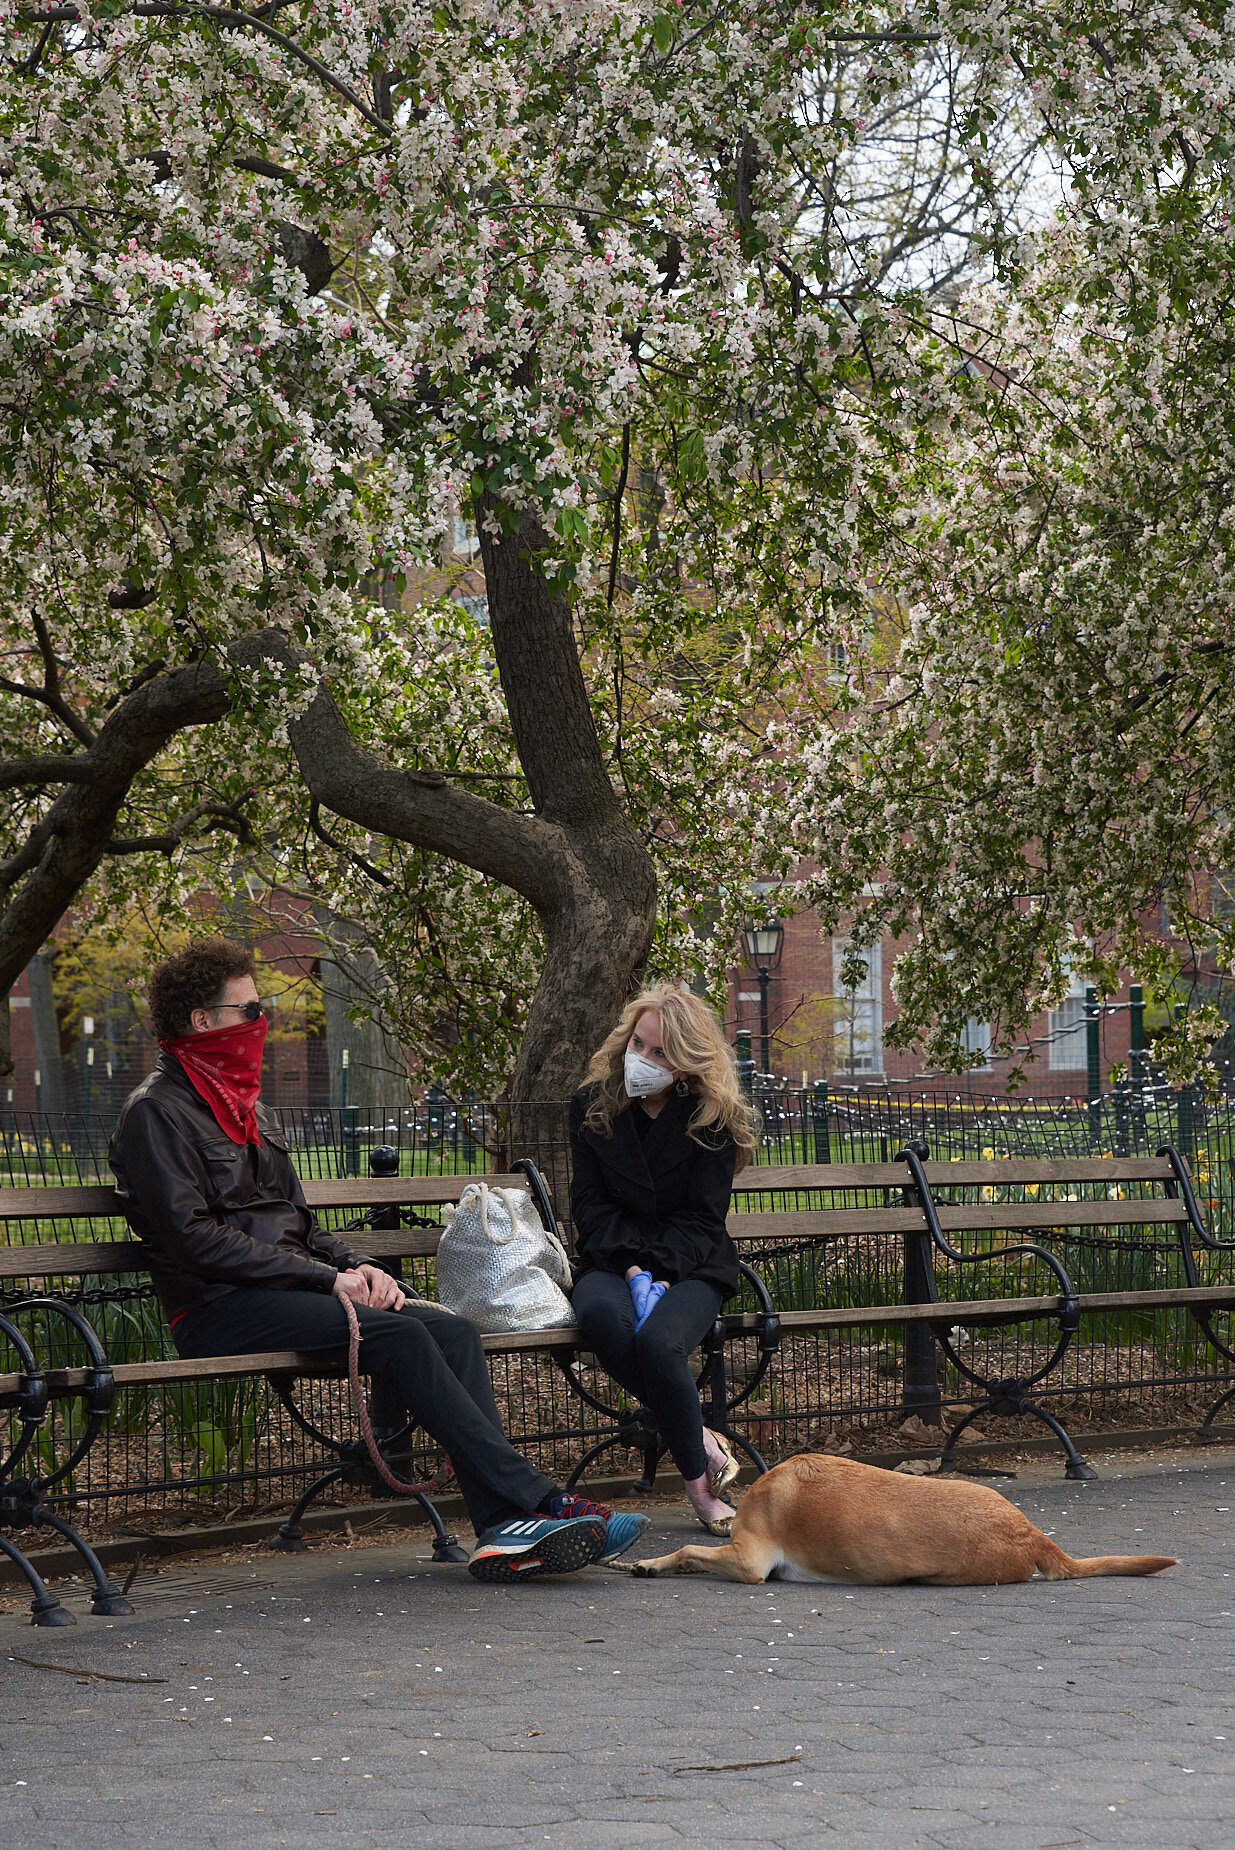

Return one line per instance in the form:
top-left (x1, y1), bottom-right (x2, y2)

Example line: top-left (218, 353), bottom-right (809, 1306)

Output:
top-left (0, 1145), bottom-right (1235, 1622)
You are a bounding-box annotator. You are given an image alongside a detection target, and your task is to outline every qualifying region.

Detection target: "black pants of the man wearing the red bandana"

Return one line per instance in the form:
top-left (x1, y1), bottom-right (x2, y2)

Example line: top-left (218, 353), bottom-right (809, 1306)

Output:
top-left (172, 1286), bottom-right (556, 1534)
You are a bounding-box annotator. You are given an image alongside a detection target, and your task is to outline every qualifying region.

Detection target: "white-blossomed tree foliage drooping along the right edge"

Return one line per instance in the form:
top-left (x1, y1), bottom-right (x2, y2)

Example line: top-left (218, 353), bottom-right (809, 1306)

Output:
top-left (780, 7), bottom-right (1235, 1082)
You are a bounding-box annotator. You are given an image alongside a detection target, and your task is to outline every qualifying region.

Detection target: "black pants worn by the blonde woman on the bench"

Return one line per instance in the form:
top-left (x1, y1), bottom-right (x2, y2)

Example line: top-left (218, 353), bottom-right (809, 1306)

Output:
top-left (571, 1271), bottom-right (725, 1478)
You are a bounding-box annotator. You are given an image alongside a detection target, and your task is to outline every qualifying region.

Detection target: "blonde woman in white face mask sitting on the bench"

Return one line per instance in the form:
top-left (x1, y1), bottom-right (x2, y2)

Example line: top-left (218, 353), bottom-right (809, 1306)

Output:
top-left (569, 982), bottom-right (754, 1536)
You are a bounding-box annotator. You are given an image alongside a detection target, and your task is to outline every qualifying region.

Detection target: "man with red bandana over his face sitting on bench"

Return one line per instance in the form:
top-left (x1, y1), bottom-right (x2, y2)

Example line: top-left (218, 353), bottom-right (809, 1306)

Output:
top-left (109, 938), bottom-right (647, 1580)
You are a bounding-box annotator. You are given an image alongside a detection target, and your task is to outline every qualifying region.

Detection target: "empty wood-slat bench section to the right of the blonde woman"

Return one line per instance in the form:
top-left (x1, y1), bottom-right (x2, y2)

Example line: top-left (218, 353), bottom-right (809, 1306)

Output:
top-left (728, 1143), bottom-right (1235, 1480)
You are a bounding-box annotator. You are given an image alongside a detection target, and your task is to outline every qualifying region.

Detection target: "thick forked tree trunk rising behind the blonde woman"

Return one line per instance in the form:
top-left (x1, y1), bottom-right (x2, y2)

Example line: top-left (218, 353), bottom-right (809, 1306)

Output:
top-left (244, 501), bottom-right (656, 1102)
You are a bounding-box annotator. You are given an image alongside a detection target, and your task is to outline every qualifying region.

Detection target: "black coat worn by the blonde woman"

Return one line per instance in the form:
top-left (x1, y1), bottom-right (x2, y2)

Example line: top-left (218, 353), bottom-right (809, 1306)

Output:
top-left (569, 1088), bottom-right (740, 1297)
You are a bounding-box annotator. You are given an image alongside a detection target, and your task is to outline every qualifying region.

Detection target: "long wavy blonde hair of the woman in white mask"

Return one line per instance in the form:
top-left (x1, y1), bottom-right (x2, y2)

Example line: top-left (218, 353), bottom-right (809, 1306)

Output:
top-left (584, 982), bottom-right (758, 1169)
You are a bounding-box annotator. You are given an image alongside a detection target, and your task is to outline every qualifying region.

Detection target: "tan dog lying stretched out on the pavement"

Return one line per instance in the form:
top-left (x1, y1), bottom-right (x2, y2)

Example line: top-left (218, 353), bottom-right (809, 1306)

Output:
top-left (630, 1452), bottom-right (1176, 1587)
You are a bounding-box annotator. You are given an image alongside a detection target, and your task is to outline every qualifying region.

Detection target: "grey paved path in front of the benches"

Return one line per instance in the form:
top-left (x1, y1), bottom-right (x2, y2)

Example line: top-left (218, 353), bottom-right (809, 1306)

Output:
top-left (0, 1452), bottom-right (1235, 1850)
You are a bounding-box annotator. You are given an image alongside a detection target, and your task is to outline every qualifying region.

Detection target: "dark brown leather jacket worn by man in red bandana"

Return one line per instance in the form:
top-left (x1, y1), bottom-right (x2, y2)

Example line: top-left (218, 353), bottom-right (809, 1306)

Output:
top-left (107, 1053), bottom-right (364, 1319)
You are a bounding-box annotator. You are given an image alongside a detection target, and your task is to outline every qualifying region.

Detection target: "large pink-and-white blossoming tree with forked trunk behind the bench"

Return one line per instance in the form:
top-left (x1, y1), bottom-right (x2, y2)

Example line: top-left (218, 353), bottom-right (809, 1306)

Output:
top-left (0, 0), bottom-right (1217, 1097)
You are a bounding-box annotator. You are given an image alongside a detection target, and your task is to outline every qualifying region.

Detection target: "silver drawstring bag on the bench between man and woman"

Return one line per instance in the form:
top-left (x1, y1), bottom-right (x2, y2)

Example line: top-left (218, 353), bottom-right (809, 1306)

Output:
top-left (438, 1182), bottom-right (575, 1336)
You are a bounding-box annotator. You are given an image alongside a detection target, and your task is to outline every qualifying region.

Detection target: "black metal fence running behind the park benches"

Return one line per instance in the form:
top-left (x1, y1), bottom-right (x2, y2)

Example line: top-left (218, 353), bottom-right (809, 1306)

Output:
top-left (0, 1079), bottom-right (1235, 1530)
